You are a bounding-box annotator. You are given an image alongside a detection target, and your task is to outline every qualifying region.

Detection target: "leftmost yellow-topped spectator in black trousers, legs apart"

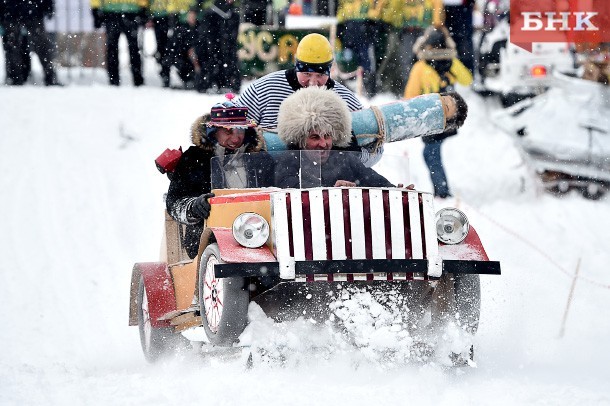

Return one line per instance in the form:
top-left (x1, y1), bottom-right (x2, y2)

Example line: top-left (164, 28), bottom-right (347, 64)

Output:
top-left (91, 0), bottom-right (149, 86)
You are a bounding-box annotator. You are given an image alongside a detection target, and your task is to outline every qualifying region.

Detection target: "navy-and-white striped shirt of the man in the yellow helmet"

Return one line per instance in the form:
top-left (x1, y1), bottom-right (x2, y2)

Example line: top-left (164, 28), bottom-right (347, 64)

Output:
top-left (233, 69), bottom-right (362, 129)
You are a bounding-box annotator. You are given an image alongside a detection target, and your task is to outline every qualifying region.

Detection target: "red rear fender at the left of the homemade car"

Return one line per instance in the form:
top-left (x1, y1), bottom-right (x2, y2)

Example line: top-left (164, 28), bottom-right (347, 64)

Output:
top-left (129, 262), bottom-right (176, 327)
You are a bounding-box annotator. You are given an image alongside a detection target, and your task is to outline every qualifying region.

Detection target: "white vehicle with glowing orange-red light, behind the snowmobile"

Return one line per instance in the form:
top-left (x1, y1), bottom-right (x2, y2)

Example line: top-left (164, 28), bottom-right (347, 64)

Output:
top-left (475, 16), bottom-right (575, 107)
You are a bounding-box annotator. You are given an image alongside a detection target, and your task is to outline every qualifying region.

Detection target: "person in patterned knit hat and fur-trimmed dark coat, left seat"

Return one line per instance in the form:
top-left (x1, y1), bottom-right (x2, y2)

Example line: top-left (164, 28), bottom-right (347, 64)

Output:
top-left (165, 101), bottom-right (273, 258)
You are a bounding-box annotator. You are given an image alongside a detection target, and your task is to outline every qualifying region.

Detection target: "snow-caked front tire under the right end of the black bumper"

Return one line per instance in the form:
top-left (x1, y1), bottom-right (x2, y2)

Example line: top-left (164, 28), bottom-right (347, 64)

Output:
top-left (453, 274), bottom-right (481, 334)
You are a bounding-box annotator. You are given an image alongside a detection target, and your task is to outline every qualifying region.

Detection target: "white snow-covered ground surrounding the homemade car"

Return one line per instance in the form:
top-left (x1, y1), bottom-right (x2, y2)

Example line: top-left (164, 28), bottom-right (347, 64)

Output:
top-left (0, 42), bottom-right (610, 405)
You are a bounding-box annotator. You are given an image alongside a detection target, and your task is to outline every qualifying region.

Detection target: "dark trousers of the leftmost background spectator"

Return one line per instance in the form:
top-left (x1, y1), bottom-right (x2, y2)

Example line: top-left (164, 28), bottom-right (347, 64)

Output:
top-left (4, 18), bottom-right (56, 85)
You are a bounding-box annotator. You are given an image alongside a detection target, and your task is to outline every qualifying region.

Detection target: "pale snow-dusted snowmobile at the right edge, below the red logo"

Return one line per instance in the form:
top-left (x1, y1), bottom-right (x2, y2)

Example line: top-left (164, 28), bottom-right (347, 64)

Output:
top-left (494, 73), bottom-right (610, 199)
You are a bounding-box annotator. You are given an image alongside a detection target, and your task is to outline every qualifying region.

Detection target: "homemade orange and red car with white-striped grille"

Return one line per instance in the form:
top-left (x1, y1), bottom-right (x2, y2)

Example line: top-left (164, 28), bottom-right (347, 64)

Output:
top-left (129, 151), bottom-right (500, 362)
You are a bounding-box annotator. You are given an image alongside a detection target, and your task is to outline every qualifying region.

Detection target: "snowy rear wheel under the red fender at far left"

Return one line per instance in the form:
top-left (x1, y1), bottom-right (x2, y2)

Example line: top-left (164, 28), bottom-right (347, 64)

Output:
top-left (137, 276), bottom-right (189, 363)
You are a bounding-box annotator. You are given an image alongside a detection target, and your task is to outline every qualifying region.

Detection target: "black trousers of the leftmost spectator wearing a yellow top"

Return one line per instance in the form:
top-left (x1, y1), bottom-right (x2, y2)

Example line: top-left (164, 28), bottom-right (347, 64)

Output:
top-left (104, 13), bottom-right (144, 86)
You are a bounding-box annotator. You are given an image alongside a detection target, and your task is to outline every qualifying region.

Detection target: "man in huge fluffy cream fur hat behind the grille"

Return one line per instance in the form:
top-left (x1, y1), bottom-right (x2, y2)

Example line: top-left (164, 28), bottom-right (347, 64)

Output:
top-left (276, 86), bottom-right (393, 188)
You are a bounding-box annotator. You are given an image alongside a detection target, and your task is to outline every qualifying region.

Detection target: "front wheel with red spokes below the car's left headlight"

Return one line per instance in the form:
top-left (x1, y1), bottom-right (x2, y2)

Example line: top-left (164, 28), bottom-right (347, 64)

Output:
top-left (198, 243), bottom-right (250, 347)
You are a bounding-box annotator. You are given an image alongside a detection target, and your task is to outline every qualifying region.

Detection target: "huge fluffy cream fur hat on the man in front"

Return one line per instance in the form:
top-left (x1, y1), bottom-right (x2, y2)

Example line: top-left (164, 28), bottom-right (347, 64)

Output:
top-left (277, 86), bottom-right (352, 148)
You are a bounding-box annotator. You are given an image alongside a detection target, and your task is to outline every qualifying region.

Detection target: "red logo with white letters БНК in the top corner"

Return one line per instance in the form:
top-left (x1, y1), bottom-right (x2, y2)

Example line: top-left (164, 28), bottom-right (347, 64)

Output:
top-left (510, 0), bottom-right (610, 51)
